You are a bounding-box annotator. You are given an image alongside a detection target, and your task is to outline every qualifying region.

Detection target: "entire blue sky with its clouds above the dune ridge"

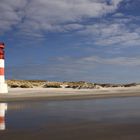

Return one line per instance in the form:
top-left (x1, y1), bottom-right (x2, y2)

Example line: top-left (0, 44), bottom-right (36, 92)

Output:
top-left (0, 0), bottom-right (140, 83)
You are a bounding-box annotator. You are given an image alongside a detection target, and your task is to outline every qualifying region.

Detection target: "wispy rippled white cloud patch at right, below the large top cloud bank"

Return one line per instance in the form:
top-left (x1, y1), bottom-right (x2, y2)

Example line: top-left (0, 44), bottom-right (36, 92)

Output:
top-left (78, 17), bottom-right (140, 46)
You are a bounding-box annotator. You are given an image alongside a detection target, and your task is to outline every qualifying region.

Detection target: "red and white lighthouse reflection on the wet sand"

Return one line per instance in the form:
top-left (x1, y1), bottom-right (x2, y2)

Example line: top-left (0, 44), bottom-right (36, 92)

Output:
top-left (0, 103), bottom-right (7, 131)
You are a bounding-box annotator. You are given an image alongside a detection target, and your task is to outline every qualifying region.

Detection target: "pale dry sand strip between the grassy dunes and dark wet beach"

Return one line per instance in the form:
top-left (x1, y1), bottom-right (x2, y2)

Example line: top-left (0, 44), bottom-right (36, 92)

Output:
top-left (0, 86), bottom-right (140, 102)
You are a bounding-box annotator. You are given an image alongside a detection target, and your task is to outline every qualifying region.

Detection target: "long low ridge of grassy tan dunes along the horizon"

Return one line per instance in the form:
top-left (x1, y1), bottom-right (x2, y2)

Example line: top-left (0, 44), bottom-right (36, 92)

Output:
top-left (7, 80), bottom-right (139, 89)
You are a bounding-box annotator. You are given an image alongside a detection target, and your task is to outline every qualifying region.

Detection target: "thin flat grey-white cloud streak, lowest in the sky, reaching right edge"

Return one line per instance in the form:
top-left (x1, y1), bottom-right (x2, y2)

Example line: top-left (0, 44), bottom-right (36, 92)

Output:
top-left (55, 56), bottom-right (140, 66)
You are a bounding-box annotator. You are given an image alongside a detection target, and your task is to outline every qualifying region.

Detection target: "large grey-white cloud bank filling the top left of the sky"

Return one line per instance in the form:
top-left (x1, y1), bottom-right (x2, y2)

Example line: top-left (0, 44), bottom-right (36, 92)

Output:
top-left (0, 0), bottom-right (123, 33)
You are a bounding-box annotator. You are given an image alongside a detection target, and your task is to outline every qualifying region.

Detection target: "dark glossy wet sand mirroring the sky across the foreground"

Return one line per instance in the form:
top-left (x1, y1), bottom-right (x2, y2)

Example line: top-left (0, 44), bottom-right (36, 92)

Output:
top-left (0, 97), bottom-right (140, 140)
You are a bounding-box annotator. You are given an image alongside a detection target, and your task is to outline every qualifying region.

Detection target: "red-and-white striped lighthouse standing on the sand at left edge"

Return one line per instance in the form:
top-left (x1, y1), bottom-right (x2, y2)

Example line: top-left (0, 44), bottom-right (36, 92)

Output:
top-left (0, 42), bottom-right (8, 94)
